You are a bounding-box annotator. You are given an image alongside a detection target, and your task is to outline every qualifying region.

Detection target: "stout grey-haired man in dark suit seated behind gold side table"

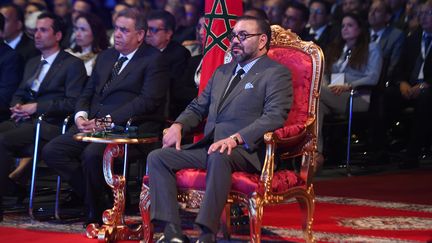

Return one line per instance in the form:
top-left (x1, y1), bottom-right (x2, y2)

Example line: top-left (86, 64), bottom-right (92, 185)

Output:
top-left (42, 8), bottom-right (169, 225)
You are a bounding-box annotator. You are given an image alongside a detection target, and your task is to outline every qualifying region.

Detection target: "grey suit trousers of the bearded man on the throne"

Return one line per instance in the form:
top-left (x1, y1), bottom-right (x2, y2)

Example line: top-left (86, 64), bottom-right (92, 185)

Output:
top-left (148, 147), bottom-right (257, 233)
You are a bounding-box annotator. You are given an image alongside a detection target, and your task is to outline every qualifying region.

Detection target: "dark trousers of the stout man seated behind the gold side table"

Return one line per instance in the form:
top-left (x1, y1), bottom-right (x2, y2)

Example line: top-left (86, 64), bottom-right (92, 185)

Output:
top-left (42, 126), bottom-right (155, 213)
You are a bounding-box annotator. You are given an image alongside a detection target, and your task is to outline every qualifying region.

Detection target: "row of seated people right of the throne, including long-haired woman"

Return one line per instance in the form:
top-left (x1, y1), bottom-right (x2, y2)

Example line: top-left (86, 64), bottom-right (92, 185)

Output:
top-left (310, 1), bottom-right (432, 171)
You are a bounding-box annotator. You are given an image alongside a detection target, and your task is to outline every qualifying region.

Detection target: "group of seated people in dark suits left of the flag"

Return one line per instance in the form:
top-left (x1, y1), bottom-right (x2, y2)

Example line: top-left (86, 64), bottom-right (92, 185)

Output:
top-left (0, 8), bottom-right (197, 226)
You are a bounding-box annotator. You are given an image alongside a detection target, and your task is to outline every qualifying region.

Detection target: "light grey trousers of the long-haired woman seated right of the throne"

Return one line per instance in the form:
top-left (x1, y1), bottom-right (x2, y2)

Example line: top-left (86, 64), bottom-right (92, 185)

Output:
top-left (318, 86), bottom-right (369, 153)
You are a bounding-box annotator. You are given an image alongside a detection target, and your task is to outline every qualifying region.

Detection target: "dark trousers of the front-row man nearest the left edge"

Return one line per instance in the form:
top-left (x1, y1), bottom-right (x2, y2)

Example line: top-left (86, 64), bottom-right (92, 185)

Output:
top-left (0, 121), bottom-right (35, 196)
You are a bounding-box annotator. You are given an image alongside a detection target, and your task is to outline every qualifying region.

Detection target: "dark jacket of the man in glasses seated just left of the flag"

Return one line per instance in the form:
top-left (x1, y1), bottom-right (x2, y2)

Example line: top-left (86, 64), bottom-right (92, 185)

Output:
top-left (162, 41), bottom-right (191, 119)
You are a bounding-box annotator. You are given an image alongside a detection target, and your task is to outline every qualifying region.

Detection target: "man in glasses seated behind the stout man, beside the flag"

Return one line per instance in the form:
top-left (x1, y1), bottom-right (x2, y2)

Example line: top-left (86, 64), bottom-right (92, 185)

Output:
top-left (146, 10), bottom-right (190, 118)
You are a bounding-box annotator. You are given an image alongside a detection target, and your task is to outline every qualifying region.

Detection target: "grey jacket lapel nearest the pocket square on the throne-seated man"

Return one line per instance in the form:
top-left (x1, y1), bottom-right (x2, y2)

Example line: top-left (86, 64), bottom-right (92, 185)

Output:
top-left (218, 56), bottom-right (268, 112)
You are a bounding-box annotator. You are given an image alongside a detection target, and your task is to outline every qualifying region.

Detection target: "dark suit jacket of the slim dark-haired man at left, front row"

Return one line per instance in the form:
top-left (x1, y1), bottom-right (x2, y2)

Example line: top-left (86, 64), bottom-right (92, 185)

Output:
top-left (11, 51), bottom-right (87, 139)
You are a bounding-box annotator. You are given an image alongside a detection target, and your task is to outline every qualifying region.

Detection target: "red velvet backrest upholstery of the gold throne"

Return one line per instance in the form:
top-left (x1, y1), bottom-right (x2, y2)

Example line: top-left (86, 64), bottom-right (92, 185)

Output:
top-left (268, 47), bottom-right (312, 139)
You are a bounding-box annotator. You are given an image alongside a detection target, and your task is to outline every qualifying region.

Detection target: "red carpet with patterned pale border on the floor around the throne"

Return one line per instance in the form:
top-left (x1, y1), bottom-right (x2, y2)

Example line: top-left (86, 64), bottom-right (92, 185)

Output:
top-left (0, 169), bottom-right (432, 243)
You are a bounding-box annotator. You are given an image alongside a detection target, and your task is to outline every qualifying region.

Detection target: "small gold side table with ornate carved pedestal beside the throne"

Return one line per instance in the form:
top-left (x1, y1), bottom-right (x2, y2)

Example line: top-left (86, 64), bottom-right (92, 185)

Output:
top-left (74, 132), bottom-right (159, 242)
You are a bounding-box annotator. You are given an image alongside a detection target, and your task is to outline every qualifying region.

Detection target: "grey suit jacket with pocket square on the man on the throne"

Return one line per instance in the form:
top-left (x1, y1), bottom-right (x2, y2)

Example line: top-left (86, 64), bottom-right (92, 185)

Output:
top-left (176, 56), bottom-right (292, 170)
